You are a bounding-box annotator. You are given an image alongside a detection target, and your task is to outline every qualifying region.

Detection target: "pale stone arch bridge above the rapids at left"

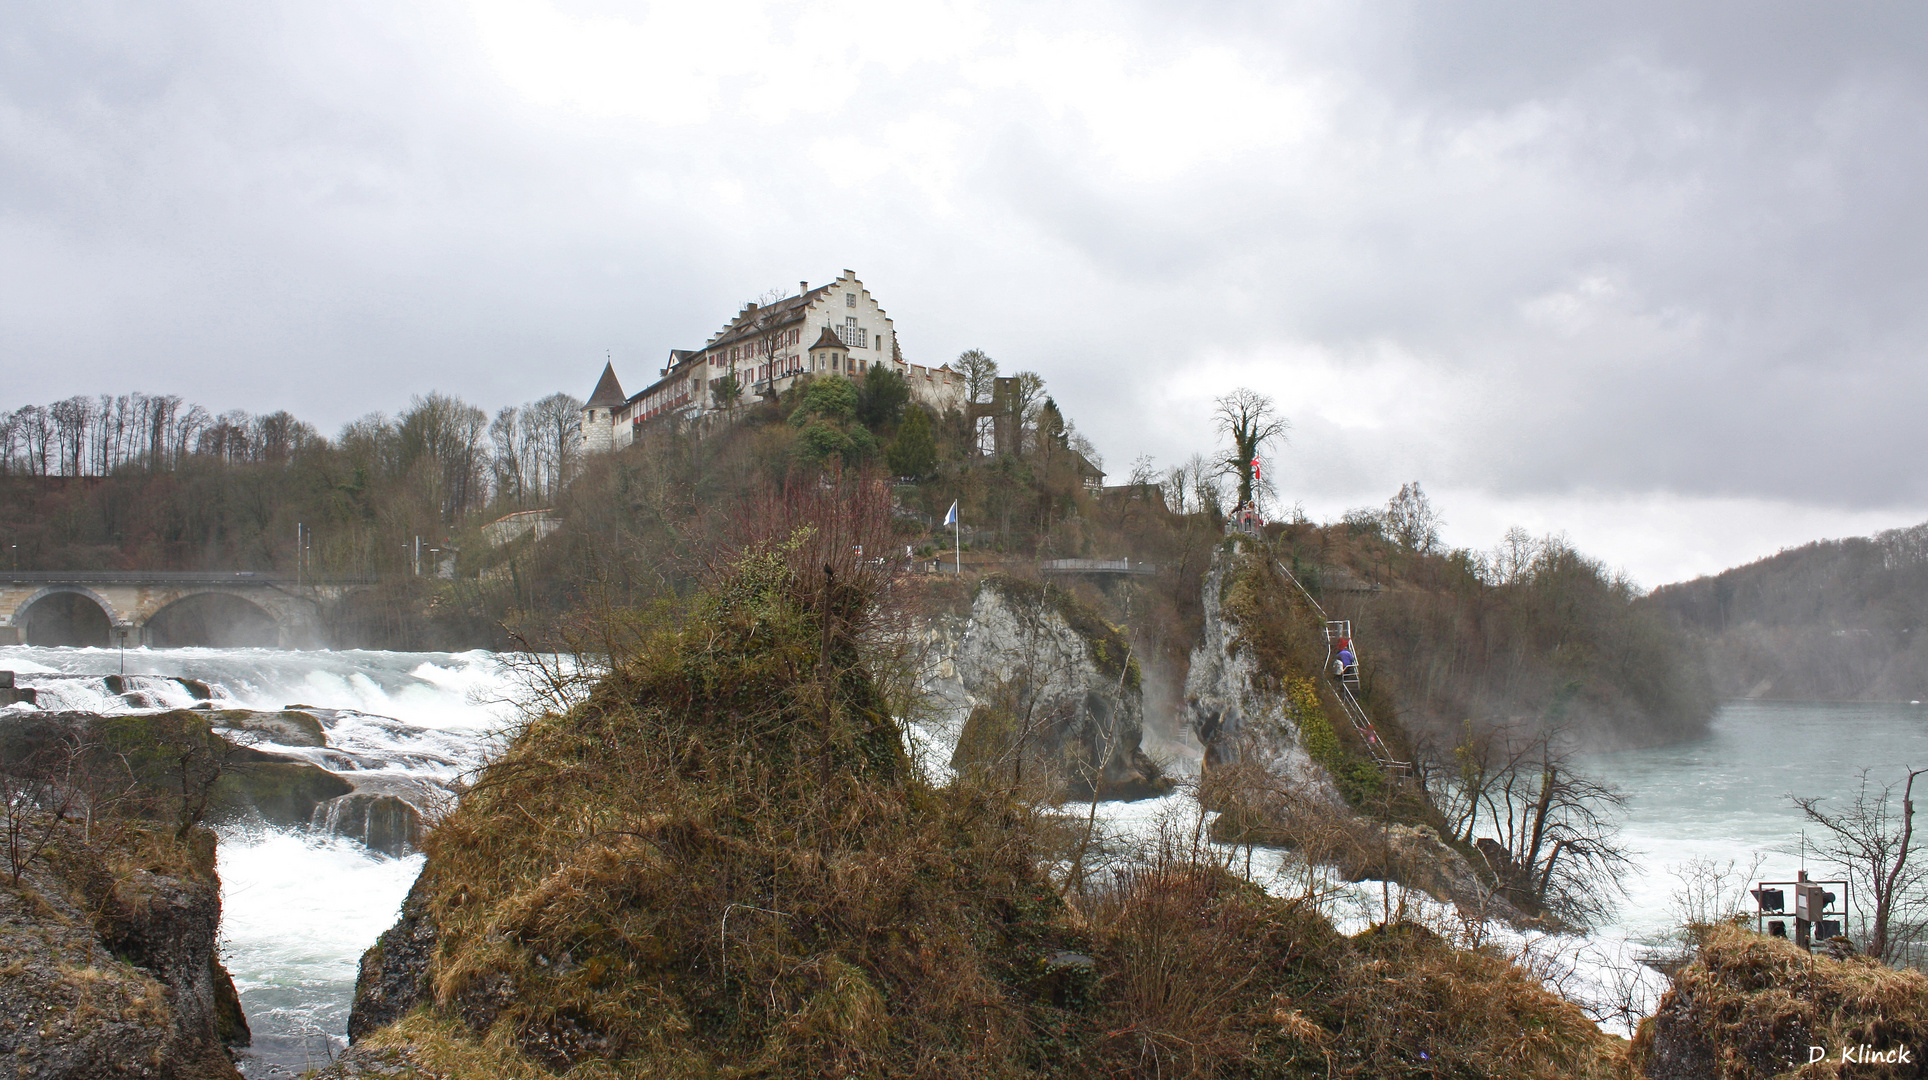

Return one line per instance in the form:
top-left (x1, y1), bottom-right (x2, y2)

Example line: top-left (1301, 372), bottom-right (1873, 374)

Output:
top-left (0, 571), bottom-right (370, 648)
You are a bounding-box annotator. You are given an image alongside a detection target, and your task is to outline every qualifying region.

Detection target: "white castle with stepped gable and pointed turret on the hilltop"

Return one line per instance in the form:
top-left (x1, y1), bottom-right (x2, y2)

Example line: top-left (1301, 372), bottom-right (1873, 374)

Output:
top-left (582, 270), bottom-right (964, 451)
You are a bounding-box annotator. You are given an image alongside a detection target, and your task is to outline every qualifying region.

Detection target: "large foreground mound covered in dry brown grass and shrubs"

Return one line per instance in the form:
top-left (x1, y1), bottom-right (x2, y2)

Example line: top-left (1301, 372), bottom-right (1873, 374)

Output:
top-left (335, 501), bottom-right (1625, 1080)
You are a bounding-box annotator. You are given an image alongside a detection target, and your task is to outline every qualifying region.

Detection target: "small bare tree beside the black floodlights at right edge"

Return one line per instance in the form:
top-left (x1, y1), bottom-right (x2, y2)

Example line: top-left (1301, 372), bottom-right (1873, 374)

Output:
top-left (1787, 770), bottom-right (1928, 960)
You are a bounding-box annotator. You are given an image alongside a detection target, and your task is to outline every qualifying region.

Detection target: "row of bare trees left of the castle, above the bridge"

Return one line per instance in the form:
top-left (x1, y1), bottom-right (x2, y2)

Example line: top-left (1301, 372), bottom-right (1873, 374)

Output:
top-left (0, 393), bottom-right (582, 575)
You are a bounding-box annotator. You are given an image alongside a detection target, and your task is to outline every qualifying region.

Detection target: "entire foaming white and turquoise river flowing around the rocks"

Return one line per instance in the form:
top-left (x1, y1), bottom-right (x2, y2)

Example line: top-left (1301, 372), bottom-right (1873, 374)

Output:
top-left (0, 646), bottom-right (1928, 1076)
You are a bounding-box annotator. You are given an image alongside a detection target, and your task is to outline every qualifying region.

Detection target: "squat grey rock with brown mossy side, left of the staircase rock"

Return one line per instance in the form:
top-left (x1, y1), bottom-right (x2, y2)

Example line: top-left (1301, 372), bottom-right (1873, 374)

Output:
top-left (927, 577), bottom-right (1170, 798)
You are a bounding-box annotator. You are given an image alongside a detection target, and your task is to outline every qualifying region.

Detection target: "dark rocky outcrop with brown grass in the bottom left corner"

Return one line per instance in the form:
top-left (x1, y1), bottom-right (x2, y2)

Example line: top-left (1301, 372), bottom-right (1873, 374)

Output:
top-left (0, 825), bottom-right (249, 1080)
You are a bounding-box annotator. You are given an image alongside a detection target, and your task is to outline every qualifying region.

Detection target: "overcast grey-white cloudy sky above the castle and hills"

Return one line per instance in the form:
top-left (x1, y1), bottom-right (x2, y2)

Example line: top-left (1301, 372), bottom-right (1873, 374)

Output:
top-left (0, 0), bottom-right (1928, 586)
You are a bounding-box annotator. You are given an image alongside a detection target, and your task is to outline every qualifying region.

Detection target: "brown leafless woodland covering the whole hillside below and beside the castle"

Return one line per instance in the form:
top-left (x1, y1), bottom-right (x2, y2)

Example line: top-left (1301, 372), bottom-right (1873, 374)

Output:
top-left (0, 366), bottom-right (1710, 746)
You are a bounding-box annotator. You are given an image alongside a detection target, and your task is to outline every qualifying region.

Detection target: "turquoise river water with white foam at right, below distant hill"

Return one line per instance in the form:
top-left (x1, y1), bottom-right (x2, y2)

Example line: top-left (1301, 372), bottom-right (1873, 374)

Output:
top-left (1579, 702), bottom-right (1928, 935)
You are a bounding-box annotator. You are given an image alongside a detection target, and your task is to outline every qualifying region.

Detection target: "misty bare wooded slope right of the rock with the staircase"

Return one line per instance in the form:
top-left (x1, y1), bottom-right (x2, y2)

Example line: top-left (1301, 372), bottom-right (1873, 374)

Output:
top-left (1278, 501), bottom-right (1716, 748)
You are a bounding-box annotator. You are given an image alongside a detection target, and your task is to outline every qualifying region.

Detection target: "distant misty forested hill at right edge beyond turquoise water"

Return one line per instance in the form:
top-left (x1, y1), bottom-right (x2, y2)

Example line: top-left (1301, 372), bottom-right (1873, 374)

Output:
top-left (1647, 525), bottom-right (1928, 702)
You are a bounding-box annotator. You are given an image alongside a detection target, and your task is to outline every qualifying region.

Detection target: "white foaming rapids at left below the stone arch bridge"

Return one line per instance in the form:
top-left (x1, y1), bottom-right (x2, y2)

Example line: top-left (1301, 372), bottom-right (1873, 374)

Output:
top-left (0, 646), bottom-right (526, 1076)
